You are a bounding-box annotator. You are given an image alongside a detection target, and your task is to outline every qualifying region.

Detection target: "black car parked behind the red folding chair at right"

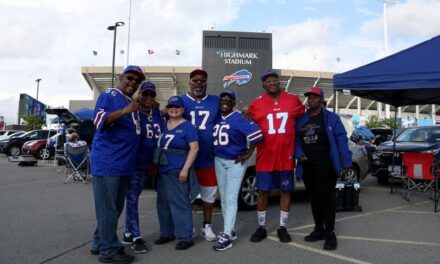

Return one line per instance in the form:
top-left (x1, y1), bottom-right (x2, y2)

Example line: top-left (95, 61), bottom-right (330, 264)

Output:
top-left (370, 126), bottom-right (440, 184)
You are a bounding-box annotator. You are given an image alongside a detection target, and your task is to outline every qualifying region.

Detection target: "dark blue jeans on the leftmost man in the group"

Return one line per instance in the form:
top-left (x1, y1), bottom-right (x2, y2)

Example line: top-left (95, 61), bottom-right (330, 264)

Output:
top-left (91, 176), bottom-right (129, 257)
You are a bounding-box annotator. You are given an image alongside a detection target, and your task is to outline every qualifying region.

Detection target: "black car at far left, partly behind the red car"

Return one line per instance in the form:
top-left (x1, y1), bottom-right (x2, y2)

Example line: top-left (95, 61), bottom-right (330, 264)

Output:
top-left (0, 129), bottom-right (56, 156)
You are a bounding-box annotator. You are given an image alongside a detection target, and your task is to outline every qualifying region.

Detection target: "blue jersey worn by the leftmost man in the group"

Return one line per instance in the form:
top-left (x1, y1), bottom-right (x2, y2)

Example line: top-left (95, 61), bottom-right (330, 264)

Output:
top-left (90, 88), bottom-right (141, 176)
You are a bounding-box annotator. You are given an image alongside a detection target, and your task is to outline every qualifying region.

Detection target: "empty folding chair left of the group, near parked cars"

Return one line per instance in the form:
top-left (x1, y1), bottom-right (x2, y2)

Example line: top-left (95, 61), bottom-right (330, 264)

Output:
top-left (64, 144), bottom-right (89, 183)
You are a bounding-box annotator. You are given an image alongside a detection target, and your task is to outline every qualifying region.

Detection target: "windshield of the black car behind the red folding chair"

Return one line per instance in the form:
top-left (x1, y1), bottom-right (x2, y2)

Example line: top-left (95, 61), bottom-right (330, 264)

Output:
top-left (396, 126), bottom-right (440, 142)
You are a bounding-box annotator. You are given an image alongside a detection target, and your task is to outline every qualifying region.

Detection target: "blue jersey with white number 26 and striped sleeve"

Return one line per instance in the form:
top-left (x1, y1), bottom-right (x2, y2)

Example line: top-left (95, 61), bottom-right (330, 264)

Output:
top-left (213, 111), bottom-right (263, 159)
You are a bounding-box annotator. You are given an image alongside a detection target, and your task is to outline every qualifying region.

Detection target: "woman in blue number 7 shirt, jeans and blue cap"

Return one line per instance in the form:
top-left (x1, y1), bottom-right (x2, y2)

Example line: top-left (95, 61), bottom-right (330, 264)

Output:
top-left (154, 96), bottom-right (199, 250)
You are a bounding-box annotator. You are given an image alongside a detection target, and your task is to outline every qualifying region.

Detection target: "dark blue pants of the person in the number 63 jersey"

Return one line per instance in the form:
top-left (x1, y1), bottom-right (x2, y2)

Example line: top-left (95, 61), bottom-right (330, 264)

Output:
top-left (125, 170), bottom-right (147, 238)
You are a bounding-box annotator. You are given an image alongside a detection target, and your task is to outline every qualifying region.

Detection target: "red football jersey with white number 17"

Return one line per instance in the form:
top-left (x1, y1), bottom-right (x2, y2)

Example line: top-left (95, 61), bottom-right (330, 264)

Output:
top-left (248, 91), bottom-right (304, 172)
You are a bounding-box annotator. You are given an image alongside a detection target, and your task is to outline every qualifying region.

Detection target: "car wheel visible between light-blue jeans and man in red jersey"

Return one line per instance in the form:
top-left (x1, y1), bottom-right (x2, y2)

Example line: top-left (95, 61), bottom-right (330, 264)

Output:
top-left (238, 167), bottom-right (258, 210)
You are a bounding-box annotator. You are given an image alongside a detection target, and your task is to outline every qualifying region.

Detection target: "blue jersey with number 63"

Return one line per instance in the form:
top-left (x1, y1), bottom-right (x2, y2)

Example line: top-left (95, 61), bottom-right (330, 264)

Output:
top-left (136, 108), bottom-right (163, 170)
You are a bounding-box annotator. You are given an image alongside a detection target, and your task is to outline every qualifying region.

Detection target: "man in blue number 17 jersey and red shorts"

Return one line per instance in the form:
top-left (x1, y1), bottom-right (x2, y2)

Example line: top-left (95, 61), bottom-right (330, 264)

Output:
top-left (182, 69), bottom-right (219, 241)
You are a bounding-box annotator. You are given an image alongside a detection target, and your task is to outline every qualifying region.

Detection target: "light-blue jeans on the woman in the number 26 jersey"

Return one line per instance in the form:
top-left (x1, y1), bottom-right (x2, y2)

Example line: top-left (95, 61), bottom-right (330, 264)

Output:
top-left (215, 156), bottom-right (247, 235)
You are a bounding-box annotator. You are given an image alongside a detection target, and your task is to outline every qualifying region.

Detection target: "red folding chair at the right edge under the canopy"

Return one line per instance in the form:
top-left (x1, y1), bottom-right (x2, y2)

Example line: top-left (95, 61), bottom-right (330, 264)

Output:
top-left (402, 152), bottom-right (440, 212)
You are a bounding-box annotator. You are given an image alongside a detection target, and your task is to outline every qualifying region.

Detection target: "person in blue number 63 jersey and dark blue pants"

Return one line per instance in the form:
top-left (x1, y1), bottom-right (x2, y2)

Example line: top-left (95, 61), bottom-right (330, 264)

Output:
top-left (122, 82), bottom-right (162, 253)
